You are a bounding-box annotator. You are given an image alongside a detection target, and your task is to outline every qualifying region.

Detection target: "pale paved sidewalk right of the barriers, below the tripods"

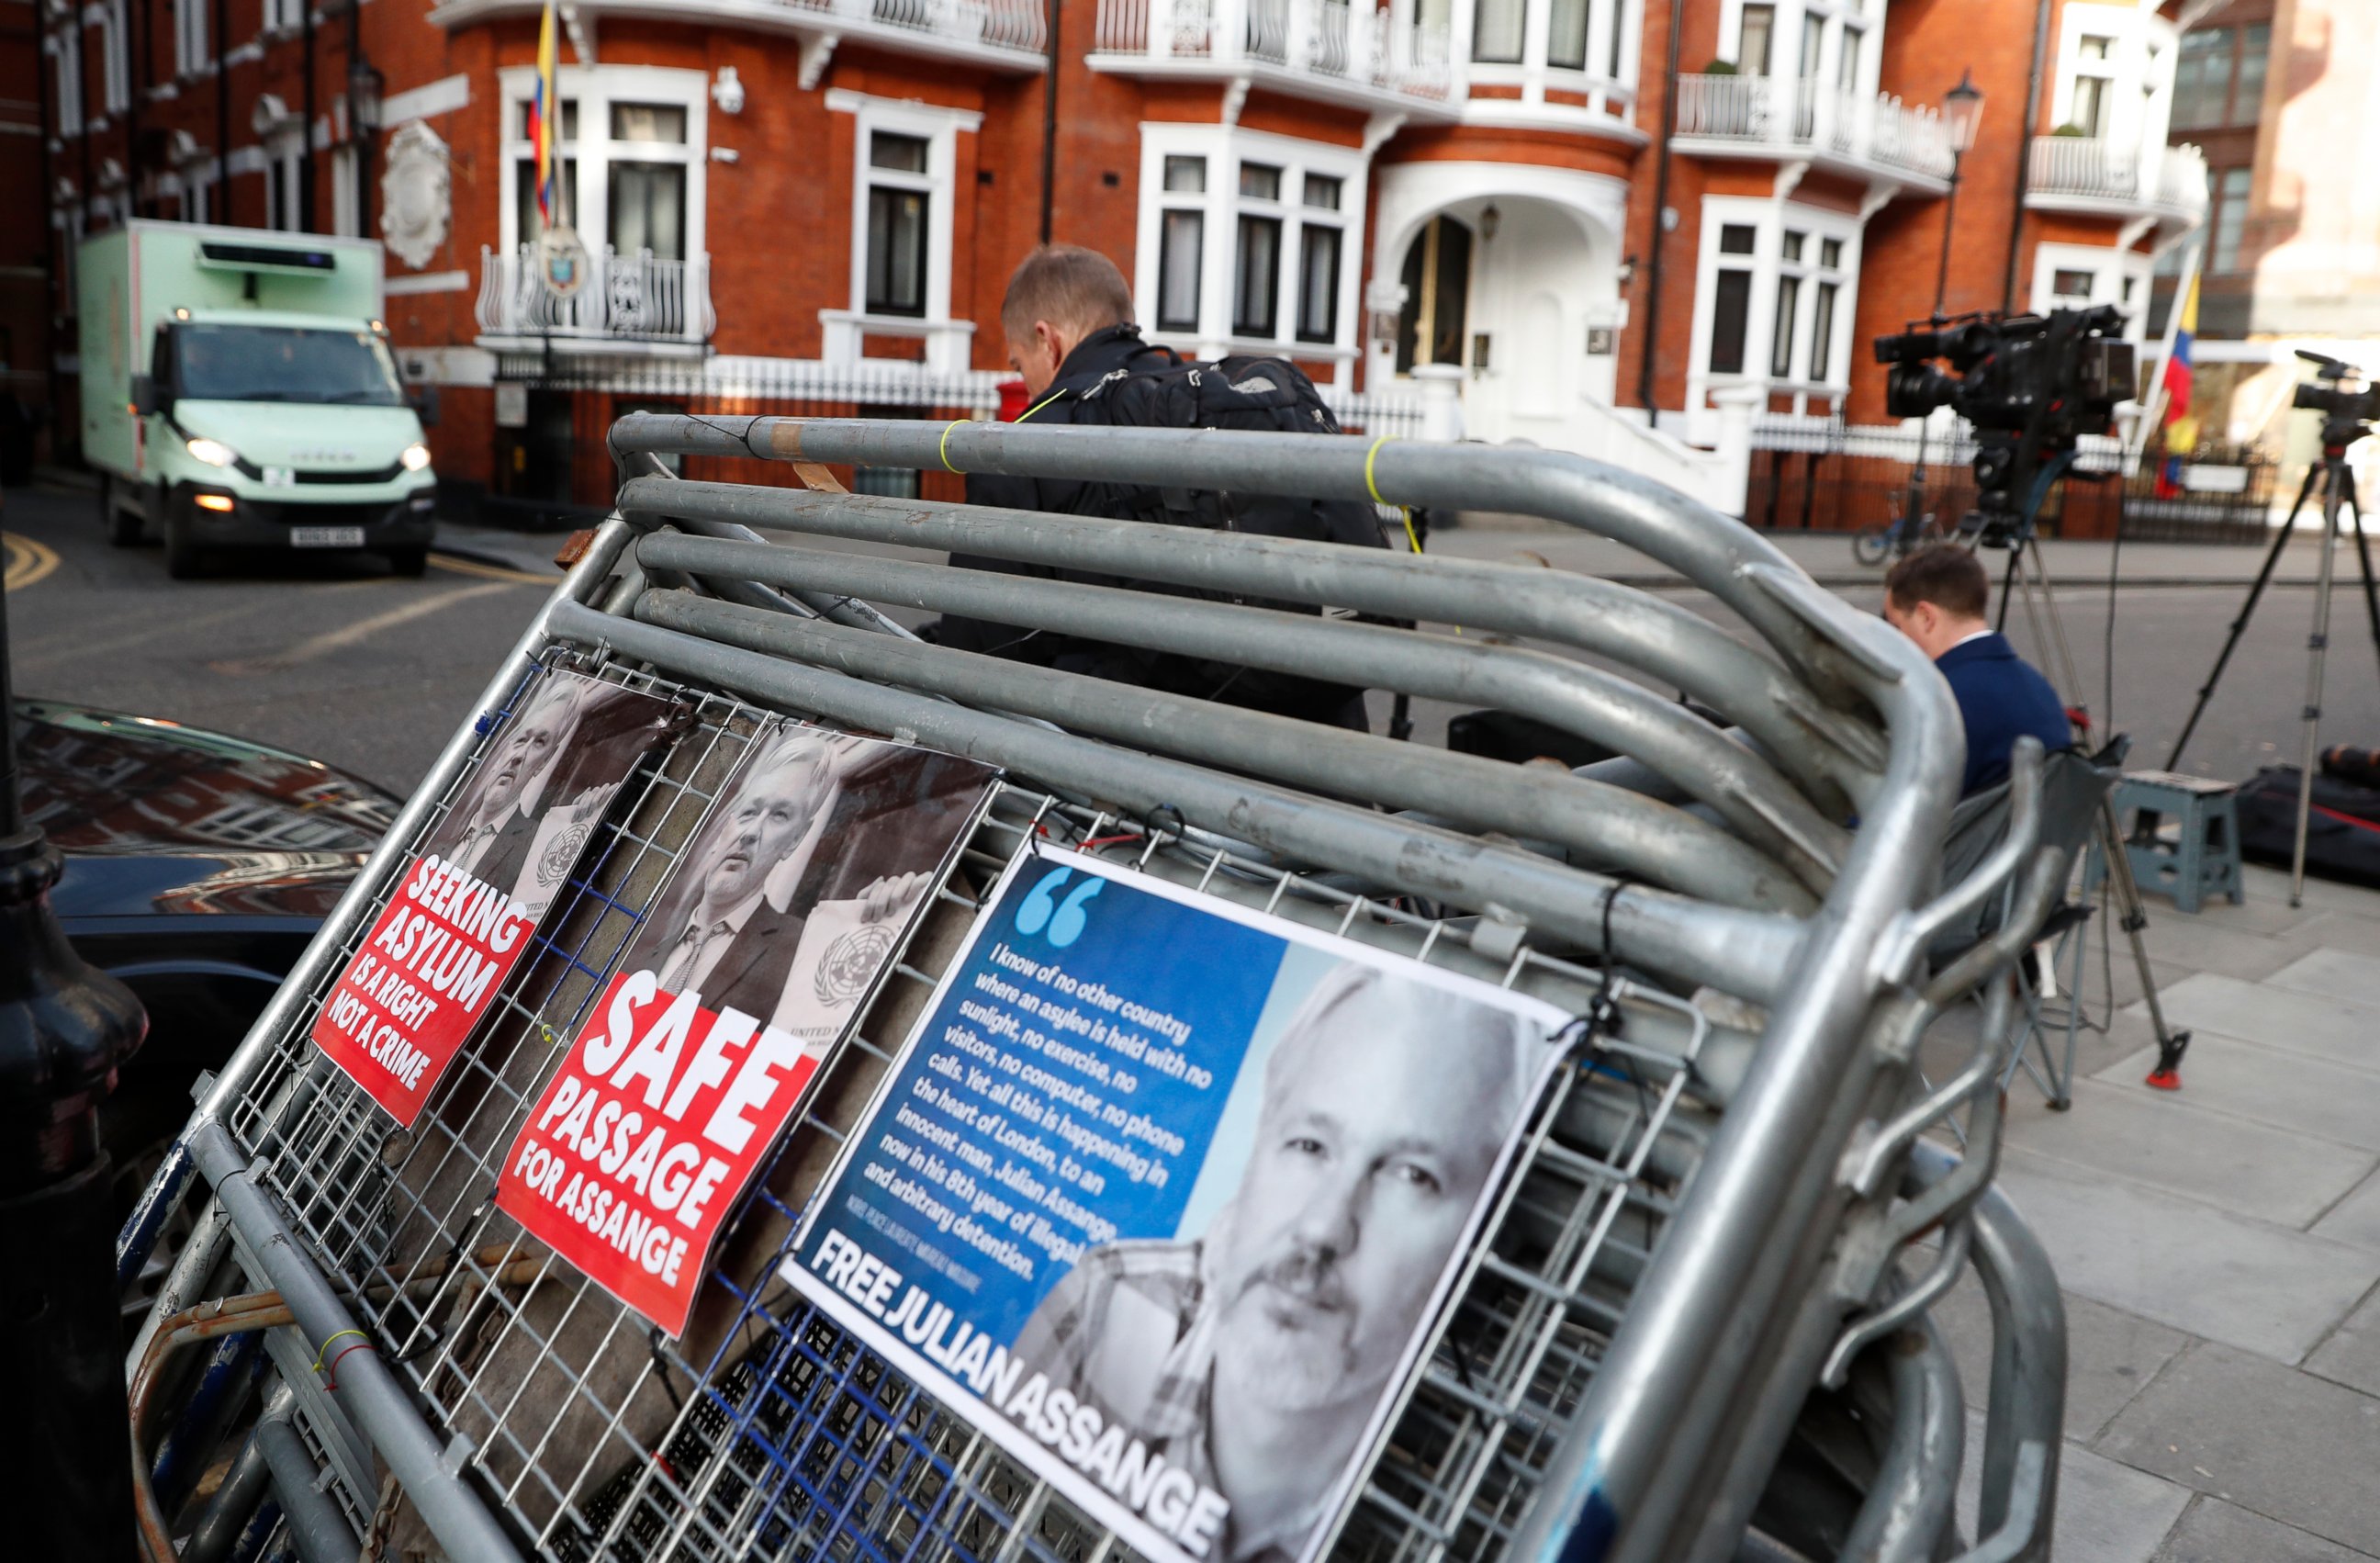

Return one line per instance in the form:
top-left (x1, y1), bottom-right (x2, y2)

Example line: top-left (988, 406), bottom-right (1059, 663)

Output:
top-left (1935, 869), bottom-right (2380, 1563)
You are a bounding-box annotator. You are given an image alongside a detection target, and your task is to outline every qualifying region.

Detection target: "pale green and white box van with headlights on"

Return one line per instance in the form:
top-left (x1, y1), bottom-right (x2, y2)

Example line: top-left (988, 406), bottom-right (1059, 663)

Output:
top-left (76, 221), bottom-right (435, 579)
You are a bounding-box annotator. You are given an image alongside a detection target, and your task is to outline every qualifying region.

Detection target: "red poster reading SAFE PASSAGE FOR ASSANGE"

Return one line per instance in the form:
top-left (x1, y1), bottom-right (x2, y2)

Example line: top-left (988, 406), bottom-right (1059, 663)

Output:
top-left (495, 728), bottom-right (993, 1337)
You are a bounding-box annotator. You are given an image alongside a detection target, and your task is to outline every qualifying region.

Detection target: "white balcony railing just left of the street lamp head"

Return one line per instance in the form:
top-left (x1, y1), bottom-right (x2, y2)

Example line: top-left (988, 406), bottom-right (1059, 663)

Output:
top-left (1678, 76), bottom-right (1949, 178)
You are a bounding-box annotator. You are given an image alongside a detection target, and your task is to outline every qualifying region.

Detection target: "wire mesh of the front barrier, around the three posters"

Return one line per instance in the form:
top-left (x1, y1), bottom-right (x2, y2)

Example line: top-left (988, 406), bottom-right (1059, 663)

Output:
top-left (185, 649), bottom-right (1704, 1560)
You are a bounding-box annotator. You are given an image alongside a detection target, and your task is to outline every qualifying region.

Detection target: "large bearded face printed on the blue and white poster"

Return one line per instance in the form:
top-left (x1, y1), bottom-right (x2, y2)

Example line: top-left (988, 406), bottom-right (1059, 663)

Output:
top-left (1211, 973), bottom-right (1523, 1411)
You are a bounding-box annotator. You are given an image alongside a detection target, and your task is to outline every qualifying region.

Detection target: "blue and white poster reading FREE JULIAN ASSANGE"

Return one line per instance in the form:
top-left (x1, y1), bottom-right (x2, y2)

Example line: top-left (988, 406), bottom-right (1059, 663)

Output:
top-left (783, 851), bottom-right (1566, 1563)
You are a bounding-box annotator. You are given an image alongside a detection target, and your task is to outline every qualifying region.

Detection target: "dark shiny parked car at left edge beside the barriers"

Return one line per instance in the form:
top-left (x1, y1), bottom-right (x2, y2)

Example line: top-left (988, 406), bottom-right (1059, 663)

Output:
top-left (17, 700), bottom-right (399, 1284)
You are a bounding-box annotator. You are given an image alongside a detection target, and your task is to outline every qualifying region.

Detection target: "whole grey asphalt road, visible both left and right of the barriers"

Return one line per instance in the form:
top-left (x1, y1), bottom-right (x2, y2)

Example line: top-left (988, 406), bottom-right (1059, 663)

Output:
top-left (5, 473), bottom-right (2380, 793)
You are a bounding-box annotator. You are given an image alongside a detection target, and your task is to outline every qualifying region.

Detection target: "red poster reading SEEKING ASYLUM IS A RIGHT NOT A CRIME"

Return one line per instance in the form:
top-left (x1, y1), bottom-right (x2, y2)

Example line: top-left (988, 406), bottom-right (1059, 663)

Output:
top-left (314, 671), bottom-right (679, 1128)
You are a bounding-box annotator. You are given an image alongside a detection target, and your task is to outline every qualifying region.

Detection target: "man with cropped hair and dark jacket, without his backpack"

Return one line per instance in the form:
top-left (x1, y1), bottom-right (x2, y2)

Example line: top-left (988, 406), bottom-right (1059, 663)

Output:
top-left (933, 245), bottom-right (1368, 730)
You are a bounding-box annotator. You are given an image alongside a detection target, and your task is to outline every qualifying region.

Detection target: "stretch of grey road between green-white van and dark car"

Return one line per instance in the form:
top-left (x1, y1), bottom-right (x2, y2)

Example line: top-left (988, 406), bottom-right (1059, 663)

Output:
top-left (5, 488), bottom-right (552, 794)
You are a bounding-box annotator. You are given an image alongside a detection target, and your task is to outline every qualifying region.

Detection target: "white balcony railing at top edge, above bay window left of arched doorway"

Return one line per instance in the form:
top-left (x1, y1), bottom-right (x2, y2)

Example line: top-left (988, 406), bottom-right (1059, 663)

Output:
top-left (1093, 0), bottom-right (1454, 97)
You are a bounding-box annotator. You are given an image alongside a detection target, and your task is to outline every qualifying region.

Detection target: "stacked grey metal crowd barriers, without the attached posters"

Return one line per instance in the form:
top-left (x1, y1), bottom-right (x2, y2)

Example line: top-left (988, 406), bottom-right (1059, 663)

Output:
top-left (121, 414), bottom-right (2066, 1563)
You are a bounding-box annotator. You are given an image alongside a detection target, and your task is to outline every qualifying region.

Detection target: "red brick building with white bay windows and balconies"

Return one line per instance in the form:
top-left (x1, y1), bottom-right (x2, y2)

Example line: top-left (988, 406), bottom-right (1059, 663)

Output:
top-left (28, 0), bottom-right (2211, 504)
